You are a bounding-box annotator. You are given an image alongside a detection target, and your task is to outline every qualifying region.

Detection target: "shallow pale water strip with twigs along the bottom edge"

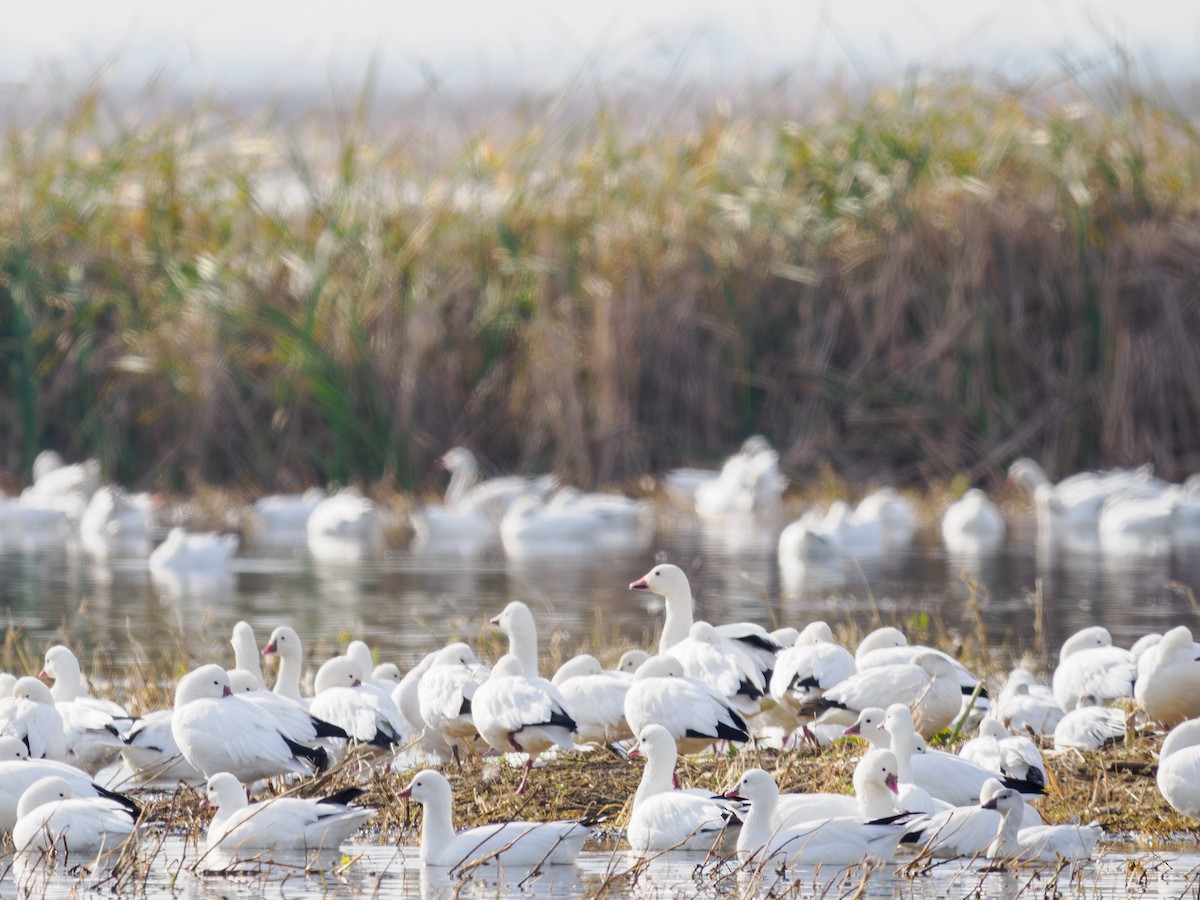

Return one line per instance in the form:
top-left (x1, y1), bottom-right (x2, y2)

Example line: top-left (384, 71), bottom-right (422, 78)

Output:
top-left (0, 836), bottom-right (1200, 900)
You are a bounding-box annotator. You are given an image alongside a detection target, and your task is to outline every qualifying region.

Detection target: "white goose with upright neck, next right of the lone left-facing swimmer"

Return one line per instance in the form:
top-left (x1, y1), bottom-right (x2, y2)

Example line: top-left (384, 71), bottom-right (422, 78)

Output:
top-left (625, 725), bottom-right (737, 854)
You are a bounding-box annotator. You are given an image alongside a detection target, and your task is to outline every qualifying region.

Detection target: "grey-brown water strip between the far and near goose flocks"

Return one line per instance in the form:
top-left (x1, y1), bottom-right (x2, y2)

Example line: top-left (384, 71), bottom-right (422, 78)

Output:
top-left (0, 515), bottom-right (1200, 670)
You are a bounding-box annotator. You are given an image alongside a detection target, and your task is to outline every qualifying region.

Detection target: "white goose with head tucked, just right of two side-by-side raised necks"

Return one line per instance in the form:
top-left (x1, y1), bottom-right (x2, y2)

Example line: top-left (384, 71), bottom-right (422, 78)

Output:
top-left (308, 656), bottom-right (404, 750)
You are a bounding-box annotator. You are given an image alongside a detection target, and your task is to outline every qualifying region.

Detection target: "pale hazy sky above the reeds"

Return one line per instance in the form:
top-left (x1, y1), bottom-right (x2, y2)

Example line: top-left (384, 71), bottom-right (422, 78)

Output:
top-left (0, 0), bottom-right (1200, 91)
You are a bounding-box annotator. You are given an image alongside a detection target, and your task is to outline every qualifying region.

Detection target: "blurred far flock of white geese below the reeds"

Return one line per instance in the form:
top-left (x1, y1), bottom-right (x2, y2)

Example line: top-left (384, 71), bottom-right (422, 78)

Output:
top-left (0, 437), bottom-right (1200, 583)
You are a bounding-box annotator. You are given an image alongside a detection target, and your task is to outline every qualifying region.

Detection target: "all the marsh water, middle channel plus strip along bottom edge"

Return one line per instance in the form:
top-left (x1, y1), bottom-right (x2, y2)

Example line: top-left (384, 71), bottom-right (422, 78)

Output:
top-left (0, 511), bottom-right (1200, 898)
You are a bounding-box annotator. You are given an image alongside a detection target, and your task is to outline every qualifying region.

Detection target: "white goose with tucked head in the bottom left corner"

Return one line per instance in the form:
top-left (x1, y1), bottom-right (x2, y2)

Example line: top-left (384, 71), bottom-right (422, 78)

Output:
top-left (12, 775), bottom-right (138, 862)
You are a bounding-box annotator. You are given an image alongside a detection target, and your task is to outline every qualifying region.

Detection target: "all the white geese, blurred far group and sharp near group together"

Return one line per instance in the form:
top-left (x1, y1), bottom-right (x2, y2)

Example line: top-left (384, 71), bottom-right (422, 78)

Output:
top-left (0, 439), bottom-right (1200, 883)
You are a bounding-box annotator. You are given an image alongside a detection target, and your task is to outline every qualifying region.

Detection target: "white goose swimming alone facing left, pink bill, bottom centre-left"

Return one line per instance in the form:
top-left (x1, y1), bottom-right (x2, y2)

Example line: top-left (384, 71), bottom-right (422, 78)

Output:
top-left (397, 769), bottom-right (592, 868)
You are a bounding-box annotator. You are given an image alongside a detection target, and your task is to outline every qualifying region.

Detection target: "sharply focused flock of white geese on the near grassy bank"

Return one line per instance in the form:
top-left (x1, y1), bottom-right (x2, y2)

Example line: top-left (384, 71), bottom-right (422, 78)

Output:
top-left (0, 564), bottom-right (1200, 868)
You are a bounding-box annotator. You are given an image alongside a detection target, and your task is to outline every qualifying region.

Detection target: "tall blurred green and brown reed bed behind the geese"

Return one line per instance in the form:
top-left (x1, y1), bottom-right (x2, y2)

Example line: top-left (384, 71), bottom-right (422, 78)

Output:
top-left (0, 68), bottom-right (1200, 488)
